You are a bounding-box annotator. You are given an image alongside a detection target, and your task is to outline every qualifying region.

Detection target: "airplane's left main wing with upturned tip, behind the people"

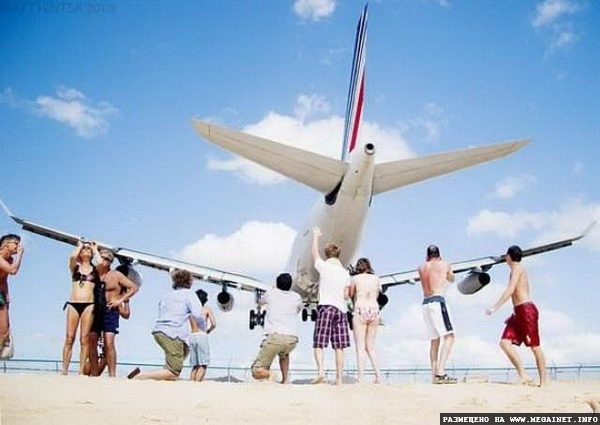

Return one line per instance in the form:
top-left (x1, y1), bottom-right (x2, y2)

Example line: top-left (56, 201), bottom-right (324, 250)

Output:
top-left (0, 200), bottom-right (272, 292)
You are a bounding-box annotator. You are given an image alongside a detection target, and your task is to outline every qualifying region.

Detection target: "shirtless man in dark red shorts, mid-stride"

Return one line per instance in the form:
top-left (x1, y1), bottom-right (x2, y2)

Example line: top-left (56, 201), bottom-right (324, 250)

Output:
top-left (485, 245), bottom-right (546, 386)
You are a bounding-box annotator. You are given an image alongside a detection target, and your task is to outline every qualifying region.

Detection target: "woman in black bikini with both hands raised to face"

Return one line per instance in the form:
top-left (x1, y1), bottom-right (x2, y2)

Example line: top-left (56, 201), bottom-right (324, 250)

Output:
top-left (62, 242), bottom-right (100, 375)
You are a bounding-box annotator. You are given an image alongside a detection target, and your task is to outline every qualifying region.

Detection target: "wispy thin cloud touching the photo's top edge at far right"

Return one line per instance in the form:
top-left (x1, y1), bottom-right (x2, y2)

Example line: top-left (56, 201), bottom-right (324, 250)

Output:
top-left (531, 0), bottom-right (586, 55)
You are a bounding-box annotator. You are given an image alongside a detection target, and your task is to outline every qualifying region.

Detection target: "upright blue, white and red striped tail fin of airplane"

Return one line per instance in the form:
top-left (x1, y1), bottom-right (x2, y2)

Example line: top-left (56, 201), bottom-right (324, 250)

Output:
top-left (342, 4), bottom-right (368, 161)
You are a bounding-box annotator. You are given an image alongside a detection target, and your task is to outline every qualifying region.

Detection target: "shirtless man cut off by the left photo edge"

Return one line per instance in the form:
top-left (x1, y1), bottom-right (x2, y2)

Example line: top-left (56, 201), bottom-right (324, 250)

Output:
top-left (0, 234), bottom-right (23, 351)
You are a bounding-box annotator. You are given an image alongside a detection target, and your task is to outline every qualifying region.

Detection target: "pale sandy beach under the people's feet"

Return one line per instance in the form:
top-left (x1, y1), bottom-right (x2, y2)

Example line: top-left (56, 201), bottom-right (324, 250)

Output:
top-left (0, 374), bottom-right (600, 425)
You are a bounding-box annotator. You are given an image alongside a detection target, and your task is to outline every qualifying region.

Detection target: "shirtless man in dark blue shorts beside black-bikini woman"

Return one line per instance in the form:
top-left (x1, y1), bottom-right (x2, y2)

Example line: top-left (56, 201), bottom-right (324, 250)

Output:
top-left (90, 249), bottom-right (138, 377)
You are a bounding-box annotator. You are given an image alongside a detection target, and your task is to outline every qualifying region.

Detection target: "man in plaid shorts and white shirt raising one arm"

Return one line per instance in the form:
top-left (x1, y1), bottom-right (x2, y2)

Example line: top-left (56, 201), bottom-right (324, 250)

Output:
top-left (312, 227), bottom-right (350, 385)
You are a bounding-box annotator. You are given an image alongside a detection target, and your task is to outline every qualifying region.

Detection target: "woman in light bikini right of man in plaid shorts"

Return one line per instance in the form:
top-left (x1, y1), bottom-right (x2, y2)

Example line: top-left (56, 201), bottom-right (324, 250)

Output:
top-left (350, 258), bottom-right (381, 384)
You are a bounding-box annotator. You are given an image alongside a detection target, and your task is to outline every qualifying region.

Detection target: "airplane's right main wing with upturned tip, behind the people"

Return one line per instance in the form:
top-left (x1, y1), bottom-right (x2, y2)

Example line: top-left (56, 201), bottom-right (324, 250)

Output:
top-left (379, 221), bottom-right (596, 293)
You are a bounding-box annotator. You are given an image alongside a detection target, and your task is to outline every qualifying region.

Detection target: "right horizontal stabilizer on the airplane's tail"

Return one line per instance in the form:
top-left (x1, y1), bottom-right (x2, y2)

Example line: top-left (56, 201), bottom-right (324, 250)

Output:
top-left (373, 140), bottom-right (529, 195)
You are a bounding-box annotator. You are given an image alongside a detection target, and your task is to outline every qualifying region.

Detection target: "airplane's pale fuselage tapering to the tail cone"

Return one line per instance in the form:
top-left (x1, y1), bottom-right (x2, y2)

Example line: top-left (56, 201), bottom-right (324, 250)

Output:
top-left (287, 143), bottom-right (375, 304)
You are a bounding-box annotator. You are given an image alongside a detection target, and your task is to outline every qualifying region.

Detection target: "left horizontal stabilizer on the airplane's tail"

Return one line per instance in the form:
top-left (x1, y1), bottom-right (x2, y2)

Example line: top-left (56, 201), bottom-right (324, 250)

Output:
top-left (192, 120), bottom-right (347, 193)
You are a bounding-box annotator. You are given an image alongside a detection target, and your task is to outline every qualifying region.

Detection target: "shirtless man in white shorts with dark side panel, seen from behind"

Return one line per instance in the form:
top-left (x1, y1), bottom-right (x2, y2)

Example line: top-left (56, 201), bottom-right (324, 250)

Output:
top-left (419, 245), bottom-right (457, 384)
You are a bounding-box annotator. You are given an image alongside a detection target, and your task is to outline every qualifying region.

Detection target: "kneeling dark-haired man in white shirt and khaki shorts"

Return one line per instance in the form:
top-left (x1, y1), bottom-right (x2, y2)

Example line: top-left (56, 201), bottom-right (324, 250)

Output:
top-left (252, 273), bottom-right (302, 384)
